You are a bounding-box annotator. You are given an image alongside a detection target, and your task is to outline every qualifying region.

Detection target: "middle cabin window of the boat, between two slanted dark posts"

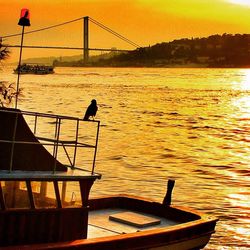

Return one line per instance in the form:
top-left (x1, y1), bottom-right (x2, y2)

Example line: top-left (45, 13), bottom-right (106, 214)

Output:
top-left (31, 181), bottom-right (57, 208)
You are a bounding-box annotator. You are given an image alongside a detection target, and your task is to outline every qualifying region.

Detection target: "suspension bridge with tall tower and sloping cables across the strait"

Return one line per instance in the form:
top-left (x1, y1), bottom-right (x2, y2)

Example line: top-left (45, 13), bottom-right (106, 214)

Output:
top-left (1, 16), bottom-right (141, 63)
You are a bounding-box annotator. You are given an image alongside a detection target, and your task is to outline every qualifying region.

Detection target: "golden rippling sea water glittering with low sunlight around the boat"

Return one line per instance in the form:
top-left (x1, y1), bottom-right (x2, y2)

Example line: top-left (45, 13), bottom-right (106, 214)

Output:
top-left (0, 67), bottom-right (250, 249)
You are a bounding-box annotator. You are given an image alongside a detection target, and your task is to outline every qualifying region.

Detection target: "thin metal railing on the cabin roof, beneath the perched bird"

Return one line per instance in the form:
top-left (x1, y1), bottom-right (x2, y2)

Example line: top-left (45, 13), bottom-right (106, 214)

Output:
top-left (0, 109), bottom-right (100, 174)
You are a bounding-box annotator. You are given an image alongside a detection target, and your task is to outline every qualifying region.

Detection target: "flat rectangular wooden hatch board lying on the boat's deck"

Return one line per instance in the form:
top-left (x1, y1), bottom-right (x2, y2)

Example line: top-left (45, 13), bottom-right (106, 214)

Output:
top-left (109, 212), bottom-right (161, 228)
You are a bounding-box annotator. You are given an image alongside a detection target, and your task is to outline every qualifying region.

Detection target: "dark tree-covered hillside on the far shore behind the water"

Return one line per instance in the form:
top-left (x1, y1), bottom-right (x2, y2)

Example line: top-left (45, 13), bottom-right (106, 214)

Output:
top-left (14, 34), bottom-right (250, 67)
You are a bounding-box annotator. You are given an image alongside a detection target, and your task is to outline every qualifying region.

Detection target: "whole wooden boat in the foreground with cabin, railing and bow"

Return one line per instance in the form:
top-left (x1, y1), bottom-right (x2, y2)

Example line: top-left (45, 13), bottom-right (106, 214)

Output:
top-left (0, 108), bottom-right (217, 250)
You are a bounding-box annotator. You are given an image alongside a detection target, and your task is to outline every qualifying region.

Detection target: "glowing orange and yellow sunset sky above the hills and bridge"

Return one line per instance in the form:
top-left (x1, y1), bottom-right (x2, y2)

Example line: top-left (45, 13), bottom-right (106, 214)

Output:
top-left (0, 0), bottom-right (250, 60)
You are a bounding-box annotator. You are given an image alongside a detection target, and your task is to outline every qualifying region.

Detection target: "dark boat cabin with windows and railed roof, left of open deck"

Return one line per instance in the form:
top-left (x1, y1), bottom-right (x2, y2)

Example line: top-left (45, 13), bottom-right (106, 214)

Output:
top-left (0, 108), bottom-right (101, 247)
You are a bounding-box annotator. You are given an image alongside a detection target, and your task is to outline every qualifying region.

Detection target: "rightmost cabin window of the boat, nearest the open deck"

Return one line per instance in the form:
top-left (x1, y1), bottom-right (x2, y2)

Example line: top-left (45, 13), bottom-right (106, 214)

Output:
top-left (58, 181), bottom-right (82, 208)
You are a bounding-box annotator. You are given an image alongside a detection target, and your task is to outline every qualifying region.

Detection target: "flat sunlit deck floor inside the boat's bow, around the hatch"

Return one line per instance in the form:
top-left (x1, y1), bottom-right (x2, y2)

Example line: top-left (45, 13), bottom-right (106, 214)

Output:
top-left (88, 208), bottom-right (179, 238)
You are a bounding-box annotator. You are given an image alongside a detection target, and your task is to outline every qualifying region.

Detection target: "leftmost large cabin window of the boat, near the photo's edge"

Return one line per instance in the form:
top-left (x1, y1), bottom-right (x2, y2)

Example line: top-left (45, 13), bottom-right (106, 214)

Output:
top-left (2, 181), bottom-right (30, 209)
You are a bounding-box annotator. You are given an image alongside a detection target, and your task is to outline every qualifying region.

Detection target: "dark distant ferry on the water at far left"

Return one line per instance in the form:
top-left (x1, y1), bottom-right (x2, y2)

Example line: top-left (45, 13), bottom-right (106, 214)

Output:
top-left (14, 63), bottom-right (55, 75)
